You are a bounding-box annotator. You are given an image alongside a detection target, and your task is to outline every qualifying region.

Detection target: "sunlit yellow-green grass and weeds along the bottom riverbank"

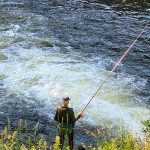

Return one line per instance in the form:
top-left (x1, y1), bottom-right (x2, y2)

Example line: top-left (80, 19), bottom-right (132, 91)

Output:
top-left (0, 120), bottom-right (150, 150)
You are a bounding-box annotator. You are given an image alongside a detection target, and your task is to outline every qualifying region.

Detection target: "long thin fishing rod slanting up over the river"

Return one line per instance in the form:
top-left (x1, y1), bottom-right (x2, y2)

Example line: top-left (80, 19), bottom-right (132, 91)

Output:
top-left (81, 26), bottom-right (147, 113)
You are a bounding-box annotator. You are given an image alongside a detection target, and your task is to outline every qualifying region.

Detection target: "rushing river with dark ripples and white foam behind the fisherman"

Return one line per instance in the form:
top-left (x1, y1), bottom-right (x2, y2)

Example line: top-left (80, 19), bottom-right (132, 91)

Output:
top-left (0, 0), bottom-right (150, 141)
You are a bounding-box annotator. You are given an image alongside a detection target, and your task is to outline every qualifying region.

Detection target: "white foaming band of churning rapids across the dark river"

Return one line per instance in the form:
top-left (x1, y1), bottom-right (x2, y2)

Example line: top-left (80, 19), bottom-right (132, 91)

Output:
top-left (0, 2), bottom-right (150, 139)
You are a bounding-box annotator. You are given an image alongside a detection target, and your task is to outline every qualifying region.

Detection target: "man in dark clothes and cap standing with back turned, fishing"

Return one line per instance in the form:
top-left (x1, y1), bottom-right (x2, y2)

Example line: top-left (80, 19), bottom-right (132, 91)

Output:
top-left (54, 97), bottom-right (83, 150)
